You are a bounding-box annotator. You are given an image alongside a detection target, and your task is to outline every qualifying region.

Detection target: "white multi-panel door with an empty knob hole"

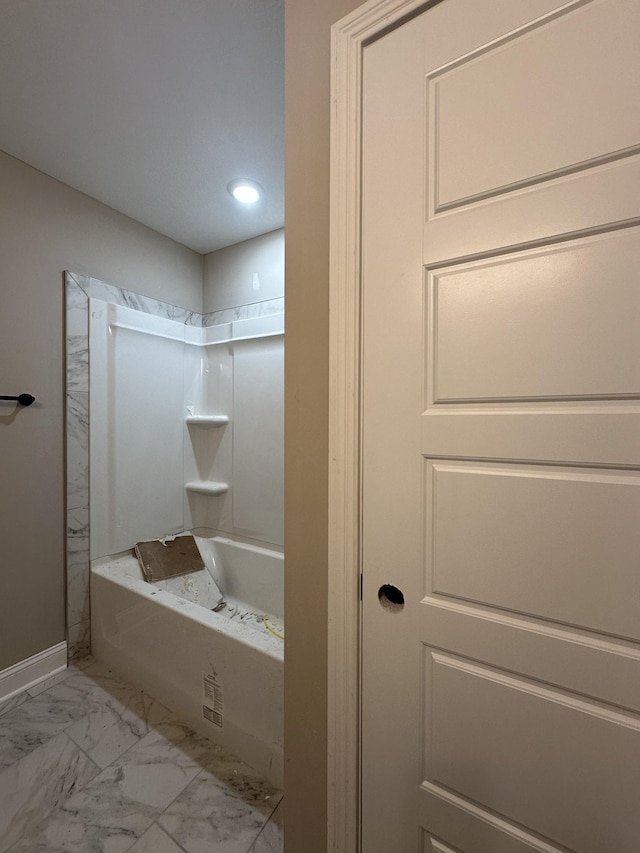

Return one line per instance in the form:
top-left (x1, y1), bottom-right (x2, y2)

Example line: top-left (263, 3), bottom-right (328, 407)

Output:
top-left (362, 0), bottom-right (640, 853)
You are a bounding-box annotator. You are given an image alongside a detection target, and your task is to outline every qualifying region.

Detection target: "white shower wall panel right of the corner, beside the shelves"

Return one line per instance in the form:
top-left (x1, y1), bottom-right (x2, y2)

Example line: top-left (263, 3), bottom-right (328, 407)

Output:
top-left (188, 306), bottom-right (284, 547)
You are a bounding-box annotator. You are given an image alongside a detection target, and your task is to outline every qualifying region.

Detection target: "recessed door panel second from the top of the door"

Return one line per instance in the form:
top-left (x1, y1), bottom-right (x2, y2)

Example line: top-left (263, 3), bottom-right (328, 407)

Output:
top-left (427, 228), bottom-right (640, 404)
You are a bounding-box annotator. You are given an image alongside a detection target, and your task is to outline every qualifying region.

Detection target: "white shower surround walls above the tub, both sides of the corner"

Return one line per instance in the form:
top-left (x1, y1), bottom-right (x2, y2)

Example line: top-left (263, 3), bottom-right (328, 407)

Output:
top-left (90, 298), bottom-right (284, 559)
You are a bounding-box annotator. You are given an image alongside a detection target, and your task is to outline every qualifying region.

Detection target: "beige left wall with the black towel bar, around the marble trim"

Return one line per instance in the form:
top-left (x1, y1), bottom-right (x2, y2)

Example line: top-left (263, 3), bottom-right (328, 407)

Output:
top-left (0, 153), bottom-right (203, 670)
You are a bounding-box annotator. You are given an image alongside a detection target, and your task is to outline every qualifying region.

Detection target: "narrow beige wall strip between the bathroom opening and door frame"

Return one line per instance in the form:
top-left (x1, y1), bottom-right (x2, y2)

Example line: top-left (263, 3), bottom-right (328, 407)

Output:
top-left (285, 0), bottom-right (360, 853)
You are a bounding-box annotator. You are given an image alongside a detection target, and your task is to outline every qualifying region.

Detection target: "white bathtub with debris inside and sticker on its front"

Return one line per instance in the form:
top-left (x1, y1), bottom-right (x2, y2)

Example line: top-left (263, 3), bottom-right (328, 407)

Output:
top-left (91, 537), bottom-right (284, 787)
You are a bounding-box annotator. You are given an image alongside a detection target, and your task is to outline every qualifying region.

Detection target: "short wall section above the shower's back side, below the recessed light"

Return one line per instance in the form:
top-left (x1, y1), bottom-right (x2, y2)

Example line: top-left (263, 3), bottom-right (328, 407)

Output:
top-left (203, 228), bottom-right (284, 313)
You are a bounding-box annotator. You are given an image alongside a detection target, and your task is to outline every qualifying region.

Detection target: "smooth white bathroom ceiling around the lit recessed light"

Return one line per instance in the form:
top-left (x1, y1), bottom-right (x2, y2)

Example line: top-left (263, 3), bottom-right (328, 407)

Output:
top-left (0, 0), bottom-right (284, 253)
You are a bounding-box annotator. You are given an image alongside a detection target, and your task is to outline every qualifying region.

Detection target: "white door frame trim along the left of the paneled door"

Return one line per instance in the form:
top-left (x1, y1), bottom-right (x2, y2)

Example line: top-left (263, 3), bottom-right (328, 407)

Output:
top-left (327, 0), bottom-right (430, 853)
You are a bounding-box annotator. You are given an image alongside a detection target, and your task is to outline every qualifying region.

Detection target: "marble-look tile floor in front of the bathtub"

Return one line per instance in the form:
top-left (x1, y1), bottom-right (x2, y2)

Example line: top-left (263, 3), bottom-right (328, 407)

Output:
top-left (0, 662), bottom-right (283, 853)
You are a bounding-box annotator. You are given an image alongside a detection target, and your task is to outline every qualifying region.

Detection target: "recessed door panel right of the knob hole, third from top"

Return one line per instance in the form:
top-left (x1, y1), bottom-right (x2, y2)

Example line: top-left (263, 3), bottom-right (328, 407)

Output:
top-left (426, 462), bottom-right (640, 640)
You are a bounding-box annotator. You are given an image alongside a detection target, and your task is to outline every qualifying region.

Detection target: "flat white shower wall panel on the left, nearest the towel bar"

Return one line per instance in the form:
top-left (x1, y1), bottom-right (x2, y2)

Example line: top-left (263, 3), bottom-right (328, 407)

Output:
top-left (90, 300), bottom-right (187, 559)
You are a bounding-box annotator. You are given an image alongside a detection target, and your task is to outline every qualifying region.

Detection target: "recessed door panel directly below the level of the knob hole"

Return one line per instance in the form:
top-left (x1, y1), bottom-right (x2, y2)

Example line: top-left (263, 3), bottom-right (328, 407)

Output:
top-left (424, 649), bottom-right (640, 853)
